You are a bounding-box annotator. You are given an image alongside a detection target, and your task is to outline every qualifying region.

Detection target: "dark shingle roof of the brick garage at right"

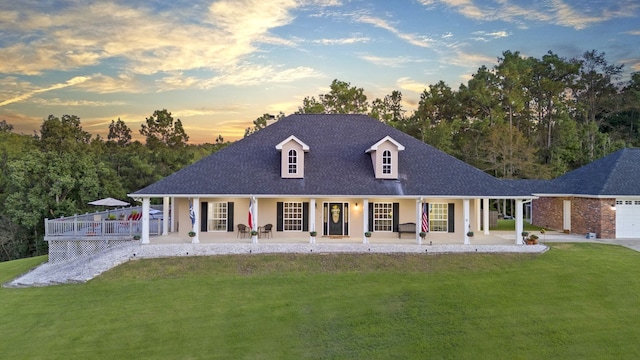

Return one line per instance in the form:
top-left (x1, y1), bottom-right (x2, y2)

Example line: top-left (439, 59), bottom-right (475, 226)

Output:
top-left (546, 148), bottom-right (640, 196)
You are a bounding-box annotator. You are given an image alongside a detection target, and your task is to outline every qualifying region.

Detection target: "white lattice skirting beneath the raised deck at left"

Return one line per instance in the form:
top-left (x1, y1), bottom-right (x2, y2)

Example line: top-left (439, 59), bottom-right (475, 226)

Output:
top-left (49, 239), bottom-right (131, 263)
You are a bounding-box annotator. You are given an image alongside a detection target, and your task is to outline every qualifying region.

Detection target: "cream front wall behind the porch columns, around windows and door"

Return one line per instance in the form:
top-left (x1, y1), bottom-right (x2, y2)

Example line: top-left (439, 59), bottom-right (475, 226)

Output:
top-left (174, 197), bottom-right (477, 242)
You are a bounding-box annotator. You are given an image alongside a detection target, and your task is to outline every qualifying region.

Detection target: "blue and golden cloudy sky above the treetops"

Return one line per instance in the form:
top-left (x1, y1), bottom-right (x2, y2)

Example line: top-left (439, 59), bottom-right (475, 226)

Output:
top-left (0, 0), bottom-right (640, 143)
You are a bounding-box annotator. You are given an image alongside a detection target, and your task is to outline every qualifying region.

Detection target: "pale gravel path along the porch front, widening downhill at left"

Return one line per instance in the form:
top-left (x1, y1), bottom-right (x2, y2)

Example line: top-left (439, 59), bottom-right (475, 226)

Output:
top-left (3, 243), bottom-right (548, 288)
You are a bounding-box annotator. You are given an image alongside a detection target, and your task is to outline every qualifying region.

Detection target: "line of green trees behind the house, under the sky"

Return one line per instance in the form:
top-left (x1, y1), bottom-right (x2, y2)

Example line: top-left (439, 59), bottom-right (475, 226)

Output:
top-left (0, 50), bottom-right (640, 261)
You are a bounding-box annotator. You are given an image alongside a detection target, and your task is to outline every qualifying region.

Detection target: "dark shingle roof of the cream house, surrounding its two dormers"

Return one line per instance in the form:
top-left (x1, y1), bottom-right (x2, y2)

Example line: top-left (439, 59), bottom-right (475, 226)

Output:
top-left (133, 114), bottom-right (528, 197)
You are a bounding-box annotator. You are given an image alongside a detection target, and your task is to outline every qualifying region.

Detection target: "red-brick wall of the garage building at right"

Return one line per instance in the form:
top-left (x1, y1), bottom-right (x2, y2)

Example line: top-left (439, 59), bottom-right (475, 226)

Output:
top-left (532, 197), bottom-right (616, 239)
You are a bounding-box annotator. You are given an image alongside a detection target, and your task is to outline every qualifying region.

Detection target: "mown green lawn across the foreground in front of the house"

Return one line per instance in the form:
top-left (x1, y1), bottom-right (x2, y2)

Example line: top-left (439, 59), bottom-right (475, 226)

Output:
top-left (0, 244), bottom-right (640, 359)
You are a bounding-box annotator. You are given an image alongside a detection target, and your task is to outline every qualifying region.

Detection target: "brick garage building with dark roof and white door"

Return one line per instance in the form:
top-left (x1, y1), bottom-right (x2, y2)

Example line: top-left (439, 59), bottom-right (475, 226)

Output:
top-left (521, 149), bottom-right (640, 239)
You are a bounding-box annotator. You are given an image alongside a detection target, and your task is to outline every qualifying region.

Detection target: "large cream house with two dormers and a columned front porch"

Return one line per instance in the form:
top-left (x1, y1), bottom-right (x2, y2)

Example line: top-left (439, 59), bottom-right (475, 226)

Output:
top-left (130, 114), bottom-right (532, 244)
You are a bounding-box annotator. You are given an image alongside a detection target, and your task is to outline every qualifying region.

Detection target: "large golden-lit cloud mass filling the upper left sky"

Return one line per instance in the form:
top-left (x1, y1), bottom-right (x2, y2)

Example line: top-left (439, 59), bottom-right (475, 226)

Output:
top-left (0, 0), bottom-right (304, 75)
